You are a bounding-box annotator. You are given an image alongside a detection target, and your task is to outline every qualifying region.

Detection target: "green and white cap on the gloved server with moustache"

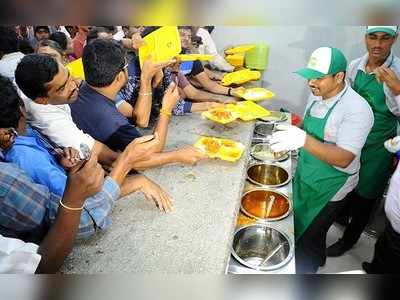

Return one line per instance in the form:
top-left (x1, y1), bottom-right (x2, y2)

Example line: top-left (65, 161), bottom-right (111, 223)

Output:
top-left (295, 47), bottom-right (347, 80)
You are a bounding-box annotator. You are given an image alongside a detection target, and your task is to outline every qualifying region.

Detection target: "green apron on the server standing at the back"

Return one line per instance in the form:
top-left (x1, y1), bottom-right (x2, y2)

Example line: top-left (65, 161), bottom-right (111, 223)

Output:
top-left (353, 70), bottom-right (397, 199)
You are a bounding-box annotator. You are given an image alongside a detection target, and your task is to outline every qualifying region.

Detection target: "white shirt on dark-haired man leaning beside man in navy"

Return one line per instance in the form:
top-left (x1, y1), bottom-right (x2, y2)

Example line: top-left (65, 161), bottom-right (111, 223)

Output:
top-left (24, 99), bottom-right (95, 156)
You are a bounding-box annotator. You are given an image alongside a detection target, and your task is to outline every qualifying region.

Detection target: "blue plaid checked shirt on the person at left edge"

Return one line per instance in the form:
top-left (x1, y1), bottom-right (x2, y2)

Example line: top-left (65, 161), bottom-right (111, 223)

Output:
top-left (0, 162), bottom-right (120, 240)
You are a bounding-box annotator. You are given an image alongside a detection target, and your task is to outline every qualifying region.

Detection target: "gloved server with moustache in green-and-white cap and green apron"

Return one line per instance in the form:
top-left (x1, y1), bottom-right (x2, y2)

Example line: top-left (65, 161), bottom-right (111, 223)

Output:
top-left (271, 47), bottom-right (373, 273)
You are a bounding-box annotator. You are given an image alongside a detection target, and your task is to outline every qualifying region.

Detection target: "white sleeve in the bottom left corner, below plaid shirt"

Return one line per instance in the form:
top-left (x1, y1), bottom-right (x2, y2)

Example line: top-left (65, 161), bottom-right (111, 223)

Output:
top-left (0, 235), bottom-right (41, 274)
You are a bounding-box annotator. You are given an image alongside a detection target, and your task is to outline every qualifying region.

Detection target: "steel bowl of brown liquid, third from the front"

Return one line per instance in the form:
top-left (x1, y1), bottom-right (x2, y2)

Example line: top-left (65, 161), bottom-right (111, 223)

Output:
top-left (247, 163), bottom-right (291, 187)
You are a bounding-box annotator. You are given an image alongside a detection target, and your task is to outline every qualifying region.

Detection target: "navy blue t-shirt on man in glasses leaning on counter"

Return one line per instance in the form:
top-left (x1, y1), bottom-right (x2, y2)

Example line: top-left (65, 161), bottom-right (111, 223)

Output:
top-left (70, 83), bottom-right (141, 150)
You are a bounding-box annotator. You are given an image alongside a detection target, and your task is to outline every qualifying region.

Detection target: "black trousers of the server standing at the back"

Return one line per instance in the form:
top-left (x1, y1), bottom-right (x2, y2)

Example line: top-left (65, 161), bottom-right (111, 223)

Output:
top-left (338, 191), bottom-right (377, 247)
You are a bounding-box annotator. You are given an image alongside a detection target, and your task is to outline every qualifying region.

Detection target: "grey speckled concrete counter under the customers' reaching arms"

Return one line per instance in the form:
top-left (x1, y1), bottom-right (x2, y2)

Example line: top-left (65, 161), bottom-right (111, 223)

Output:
top-left (62, 114), bottom-right (254, 274)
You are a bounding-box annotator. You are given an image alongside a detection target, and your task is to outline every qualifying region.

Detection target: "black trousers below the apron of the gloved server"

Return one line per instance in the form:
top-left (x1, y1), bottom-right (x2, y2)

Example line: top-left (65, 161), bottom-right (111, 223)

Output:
top-left (295, 200), bottom-right (345, 274)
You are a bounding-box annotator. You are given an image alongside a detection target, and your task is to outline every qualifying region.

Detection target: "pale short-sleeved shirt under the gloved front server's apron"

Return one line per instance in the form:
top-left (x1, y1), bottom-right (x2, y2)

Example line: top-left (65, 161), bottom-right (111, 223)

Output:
top-left (304, 84), bottom-right (374, 201)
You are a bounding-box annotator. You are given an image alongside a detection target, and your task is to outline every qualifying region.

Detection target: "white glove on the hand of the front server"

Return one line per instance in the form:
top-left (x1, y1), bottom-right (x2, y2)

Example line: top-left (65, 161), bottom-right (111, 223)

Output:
top-left (269, 124), bottom-right (307, 152)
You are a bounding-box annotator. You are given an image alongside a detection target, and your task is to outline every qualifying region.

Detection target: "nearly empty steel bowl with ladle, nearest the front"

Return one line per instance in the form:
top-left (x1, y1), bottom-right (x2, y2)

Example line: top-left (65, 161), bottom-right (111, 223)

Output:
top-left (232, 224), bottom-right (294, 271)
